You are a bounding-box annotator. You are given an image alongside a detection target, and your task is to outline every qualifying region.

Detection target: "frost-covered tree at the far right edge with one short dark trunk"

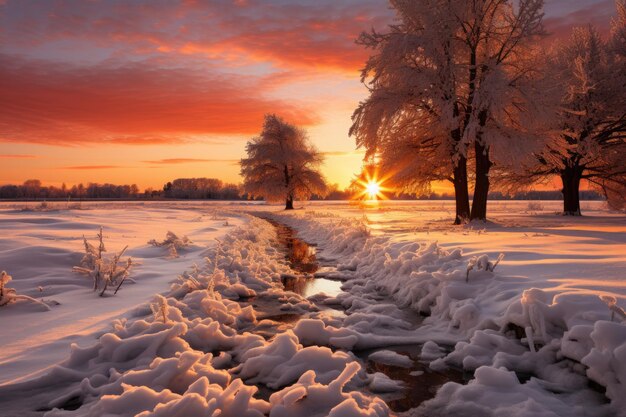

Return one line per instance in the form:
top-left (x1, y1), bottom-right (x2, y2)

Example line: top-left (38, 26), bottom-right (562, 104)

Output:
top-left (528, 19), bottom-right (626, 216)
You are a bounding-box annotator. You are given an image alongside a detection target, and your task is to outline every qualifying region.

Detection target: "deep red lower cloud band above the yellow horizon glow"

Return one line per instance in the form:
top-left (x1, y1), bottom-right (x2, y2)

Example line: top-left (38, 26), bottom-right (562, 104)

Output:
top-left (0, 55), bottom-right (317, 145)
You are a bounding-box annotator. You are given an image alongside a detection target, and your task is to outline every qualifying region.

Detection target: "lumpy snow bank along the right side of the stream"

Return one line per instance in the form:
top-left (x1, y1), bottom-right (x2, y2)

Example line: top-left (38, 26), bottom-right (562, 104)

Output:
top-left (273, 213), bottom-right (626, 415)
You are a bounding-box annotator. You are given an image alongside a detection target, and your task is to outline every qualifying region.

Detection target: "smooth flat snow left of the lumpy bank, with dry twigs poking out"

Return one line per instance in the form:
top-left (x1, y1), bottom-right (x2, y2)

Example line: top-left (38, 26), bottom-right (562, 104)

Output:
top-left (0, 203), bottom-right (242, 383)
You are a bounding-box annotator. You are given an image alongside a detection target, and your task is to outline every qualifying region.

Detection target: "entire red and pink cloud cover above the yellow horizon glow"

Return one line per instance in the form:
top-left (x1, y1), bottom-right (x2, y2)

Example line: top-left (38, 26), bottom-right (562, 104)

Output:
top-left (0, 0), bottom-right (614, 152)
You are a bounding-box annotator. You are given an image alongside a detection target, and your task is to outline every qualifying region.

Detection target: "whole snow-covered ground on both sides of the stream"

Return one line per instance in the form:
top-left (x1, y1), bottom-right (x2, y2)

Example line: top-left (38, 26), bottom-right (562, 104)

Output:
top-left (0, 201), bottom-right (626, 417)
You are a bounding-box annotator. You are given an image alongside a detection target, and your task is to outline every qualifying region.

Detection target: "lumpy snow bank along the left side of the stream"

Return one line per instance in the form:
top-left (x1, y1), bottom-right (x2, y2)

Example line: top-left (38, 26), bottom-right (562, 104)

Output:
top-left (0, 213), bottom-right (389, 417)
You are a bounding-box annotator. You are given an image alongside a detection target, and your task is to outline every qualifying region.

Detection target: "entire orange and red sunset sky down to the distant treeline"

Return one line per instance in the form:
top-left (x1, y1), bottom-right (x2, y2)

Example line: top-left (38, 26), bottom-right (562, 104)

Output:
top-left (0, 0), bottom-right (615, 189)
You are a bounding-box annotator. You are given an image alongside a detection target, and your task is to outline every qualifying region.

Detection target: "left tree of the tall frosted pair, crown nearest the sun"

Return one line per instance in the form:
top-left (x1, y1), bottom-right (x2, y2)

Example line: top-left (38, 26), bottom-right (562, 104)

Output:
top-left (350, 0), bottom-right (470, 224)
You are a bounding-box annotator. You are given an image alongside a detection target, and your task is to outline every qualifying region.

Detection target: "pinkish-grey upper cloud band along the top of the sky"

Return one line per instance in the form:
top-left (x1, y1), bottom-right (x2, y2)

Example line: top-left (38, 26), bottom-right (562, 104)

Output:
top-left (5, 0), bottom-right (393, 72)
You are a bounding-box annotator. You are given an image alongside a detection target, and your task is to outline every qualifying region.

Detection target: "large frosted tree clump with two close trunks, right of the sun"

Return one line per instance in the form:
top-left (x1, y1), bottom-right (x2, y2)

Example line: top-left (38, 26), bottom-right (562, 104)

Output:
top-left (350, 0), bottom-right (543, 224)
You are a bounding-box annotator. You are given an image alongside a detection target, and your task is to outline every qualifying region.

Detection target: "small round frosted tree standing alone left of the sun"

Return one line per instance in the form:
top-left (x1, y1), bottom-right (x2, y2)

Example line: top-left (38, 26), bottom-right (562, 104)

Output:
top-left (241, 114), bottom-right (326, 210)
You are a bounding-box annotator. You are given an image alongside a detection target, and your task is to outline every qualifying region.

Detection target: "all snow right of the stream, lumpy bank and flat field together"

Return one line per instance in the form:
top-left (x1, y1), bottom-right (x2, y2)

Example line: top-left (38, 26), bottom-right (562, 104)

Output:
top-left (260, 202), bottom-right (626, 415)
